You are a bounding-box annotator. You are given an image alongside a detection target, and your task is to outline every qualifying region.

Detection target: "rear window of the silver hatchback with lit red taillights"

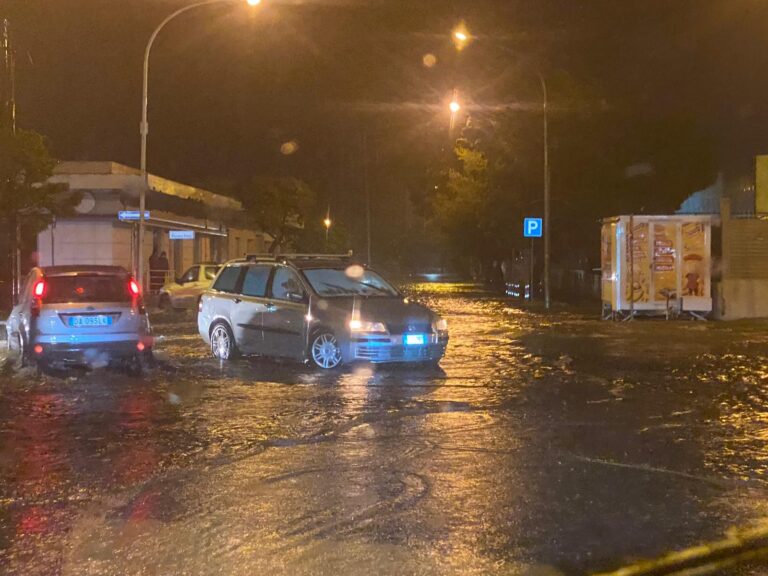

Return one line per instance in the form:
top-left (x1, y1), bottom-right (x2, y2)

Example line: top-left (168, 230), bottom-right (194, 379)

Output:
top-left (44, 274), bottom-right (132, 304)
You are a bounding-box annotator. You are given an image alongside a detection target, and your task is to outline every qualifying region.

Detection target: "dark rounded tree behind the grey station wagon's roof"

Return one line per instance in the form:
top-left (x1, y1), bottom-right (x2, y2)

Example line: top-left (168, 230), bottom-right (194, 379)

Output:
top-left (237, 177), bottom-right (317, 252)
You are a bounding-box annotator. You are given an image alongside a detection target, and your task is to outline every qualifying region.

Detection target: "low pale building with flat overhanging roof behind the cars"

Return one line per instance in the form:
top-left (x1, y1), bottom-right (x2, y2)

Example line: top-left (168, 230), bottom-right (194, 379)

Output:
top-left (36, 162), bottom-right (270, 288)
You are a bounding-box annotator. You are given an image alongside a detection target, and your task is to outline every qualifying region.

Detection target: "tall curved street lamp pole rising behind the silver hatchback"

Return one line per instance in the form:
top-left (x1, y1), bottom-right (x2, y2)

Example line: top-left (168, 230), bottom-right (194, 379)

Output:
top-left (141, 0), bottom-right (262, 288)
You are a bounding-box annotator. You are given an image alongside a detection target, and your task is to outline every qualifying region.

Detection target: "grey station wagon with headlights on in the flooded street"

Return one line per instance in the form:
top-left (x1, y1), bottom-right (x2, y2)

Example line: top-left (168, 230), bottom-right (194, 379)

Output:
top-left (198, 255), bottom-right (448, 369)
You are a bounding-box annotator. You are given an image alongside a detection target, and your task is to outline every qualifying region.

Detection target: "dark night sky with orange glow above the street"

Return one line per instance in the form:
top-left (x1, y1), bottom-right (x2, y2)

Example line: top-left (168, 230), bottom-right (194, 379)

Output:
top-left (3, 0), bottom-right (768, 212)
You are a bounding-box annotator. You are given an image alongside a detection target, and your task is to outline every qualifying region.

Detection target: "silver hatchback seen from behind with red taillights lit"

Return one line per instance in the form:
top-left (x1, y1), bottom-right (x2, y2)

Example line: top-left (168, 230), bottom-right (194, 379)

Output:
top-left (6, 266), bottom-right (153, 369)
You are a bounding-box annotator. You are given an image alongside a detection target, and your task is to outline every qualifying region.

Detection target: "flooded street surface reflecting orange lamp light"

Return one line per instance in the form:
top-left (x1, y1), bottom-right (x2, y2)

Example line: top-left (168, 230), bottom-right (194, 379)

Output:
top-left (0, 285), bottom-right (768, 576)
